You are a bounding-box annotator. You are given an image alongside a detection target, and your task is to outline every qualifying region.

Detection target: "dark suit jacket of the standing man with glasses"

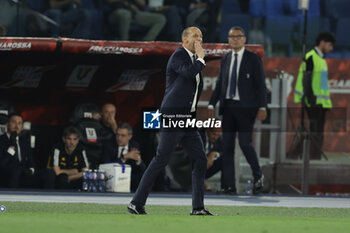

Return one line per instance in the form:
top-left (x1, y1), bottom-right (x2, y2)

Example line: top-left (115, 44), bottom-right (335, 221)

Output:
top-left (209, 49), bottom-right (267, 115)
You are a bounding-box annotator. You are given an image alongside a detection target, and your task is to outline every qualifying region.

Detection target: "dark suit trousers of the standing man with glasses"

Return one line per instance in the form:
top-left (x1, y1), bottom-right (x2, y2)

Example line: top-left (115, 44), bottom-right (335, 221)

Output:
top-left (222, 100), bottom-right (262, 189)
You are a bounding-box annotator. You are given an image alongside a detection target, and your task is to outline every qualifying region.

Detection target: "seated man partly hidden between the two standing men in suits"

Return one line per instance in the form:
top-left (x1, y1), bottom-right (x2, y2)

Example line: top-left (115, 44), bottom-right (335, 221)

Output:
top-left (200, 128), bottom-right (222, 190)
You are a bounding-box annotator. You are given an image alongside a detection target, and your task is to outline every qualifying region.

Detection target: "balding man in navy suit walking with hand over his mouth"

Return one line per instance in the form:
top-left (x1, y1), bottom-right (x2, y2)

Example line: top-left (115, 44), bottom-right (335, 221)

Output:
top-left (127, 27), bottom-right (212, 215)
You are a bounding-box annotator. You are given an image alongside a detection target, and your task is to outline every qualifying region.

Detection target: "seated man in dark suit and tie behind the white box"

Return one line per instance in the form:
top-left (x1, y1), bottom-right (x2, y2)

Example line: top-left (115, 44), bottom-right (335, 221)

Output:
top-left (102, 123), bottom-right (146, 191)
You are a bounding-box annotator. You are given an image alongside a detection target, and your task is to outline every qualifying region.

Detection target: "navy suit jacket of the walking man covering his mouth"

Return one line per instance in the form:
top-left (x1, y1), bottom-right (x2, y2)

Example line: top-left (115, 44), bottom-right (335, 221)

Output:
top-left (160, 47), bottom-right (205, 114)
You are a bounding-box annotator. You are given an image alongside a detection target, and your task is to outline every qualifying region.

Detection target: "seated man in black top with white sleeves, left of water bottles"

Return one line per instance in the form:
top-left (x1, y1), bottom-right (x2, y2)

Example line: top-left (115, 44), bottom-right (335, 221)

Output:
top-left (51, 126), bottom-right (89, 189)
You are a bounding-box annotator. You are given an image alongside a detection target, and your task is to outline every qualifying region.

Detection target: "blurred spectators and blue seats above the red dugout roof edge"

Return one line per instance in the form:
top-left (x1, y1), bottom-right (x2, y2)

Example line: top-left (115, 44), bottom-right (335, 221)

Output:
top-left (0, 0), bottom-right (350, 58)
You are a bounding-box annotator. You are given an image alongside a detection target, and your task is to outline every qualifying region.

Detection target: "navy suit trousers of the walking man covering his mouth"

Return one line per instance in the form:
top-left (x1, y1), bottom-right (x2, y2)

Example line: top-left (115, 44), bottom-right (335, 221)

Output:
top-left (132, 129), bottom-right (207, 209)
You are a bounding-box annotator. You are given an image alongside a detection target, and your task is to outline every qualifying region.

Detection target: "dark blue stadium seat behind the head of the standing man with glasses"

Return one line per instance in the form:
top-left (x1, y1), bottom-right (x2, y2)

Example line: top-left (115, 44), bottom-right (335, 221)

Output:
top-left (220, 14), bottom-right (251, 43)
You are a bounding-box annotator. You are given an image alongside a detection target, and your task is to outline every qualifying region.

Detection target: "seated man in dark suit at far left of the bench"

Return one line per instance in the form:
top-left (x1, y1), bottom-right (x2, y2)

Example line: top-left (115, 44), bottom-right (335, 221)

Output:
top-left (0, 113), bottom-right (55, 189)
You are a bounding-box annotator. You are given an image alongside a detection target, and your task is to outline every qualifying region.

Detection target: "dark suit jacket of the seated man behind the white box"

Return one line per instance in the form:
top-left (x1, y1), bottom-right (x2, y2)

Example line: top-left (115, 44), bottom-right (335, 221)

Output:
top-left (101, 138), bottom-right (146, 172)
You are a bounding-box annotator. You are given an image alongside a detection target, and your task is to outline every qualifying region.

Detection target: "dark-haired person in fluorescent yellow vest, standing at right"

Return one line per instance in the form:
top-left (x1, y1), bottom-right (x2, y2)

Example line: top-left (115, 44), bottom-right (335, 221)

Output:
top-left (294, 32), bottom-right (335, 159)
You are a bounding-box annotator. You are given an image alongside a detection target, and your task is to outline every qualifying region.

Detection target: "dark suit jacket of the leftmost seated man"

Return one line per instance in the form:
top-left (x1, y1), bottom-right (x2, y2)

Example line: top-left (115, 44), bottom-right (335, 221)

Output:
top-left (0, 134), bottom-right (35, 169)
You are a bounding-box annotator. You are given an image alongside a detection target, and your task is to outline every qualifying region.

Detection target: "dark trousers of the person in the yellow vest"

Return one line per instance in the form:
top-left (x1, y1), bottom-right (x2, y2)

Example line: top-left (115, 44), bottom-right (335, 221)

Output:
top-left (305, 106), bottom-right (327, 159)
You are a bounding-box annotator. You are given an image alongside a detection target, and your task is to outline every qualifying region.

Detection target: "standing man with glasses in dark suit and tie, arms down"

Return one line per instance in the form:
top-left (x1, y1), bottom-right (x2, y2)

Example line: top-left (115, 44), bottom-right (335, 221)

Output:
top-left (208, 27), bottom-right (266, 195)
